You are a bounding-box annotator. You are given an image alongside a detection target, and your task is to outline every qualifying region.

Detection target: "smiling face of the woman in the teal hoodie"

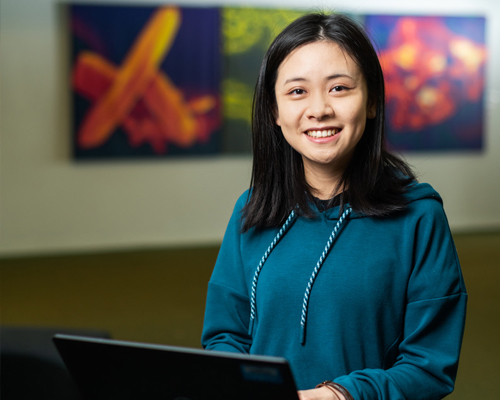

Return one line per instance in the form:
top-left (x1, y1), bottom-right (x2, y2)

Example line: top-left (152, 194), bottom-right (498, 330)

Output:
top-left (275, 40), bottom-right (376, 179)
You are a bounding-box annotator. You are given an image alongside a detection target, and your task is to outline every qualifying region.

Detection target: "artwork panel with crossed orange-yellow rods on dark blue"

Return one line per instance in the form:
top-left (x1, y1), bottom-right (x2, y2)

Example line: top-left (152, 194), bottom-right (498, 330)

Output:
top-left (69, 5), bottom-right (222, 160)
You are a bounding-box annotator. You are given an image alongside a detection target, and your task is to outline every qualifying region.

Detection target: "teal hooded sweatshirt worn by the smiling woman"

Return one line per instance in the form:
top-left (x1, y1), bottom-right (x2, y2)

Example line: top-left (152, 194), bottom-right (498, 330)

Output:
top-left (202, 184), bottom-right (467, 400)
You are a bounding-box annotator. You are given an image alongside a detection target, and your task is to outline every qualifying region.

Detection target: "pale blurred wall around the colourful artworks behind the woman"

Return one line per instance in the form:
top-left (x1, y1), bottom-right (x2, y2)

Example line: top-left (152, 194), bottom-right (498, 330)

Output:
top-left (0, 0), bottom-right (500, 256)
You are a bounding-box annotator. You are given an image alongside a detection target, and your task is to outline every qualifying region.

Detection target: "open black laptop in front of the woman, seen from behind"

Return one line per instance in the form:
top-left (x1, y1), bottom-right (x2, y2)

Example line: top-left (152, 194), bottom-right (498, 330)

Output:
top-left (53, 334), bottom-right (298, 400)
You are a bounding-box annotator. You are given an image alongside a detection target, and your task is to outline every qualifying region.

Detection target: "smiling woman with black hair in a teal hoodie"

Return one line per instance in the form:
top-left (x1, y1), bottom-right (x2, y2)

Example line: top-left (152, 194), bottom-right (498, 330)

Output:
top-left (202, 14), bottom-right (467, 400)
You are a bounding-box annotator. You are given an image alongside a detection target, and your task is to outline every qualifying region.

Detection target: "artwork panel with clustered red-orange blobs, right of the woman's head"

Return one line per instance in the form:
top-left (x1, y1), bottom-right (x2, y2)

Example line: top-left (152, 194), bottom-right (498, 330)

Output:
top-left (365, 15), bottom-right (487, 152)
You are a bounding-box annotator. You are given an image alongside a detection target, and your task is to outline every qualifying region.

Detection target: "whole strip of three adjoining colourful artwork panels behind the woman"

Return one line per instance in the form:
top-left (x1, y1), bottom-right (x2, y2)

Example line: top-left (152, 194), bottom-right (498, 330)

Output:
top-left (69, 5), bottom-right (487, 160)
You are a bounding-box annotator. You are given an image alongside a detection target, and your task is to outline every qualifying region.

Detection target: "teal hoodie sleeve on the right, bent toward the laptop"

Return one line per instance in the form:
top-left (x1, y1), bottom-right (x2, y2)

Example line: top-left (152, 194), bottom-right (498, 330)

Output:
top-left (335, 200), bottom-right (467, 400)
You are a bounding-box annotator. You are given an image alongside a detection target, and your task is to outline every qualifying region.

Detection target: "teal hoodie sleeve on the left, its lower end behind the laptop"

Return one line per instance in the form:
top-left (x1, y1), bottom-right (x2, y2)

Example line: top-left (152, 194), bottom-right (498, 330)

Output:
top-left (201, 193), bottom-right (252, 353)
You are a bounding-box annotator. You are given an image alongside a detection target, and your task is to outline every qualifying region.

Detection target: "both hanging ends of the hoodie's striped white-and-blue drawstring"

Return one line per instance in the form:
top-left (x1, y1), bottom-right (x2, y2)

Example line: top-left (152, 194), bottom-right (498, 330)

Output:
top-left (248, 207), bottom-right (352, 344)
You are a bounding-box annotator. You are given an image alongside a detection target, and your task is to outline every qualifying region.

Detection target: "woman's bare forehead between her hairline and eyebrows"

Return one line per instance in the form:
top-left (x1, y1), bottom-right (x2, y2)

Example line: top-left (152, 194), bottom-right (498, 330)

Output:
top-left (277, 40), bottom-right (363, 80)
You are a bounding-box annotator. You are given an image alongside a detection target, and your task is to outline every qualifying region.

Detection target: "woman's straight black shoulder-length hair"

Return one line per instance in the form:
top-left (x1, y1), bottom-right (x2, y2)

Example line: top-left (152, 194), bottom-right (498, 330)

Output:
top-left (242, 13), bottom-right (415, 231)
